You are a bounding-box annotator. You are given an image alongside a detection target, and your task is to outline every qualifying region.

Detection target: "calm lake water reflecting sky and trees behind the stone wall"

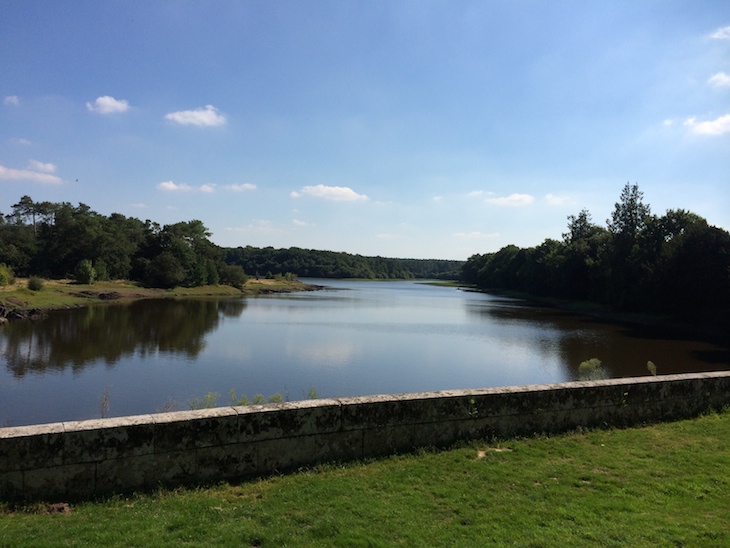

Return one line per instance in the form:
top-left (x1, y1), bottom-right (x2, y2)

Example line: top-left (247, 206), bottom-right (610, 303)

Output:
top-left (0, 280), bottom-right (730, 426)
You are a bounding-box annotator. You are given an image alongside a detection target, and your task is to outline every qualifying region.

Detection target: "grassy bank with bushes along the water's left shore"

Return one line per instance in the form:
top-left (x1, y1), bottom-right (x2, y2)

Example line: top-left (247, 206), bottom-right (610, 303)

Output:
top-left (0, 279), bottom-right (312, 310)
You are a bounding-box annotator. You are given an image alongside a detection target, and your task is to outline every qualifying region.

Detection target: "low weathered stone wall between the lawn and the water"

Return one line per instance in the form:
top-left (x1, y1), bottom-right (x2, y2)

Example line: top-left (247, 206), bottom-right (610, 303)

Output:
top-left (0, 372), bottom-right (730, 500)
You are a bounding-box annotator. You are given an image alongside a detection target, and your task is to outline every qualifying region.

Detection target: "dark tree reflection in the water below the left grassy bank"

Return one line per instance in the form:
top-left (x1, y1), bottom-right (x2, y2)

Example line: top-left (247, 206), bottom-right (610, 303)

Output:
top-left (0, 299), bottom-right (246, 377)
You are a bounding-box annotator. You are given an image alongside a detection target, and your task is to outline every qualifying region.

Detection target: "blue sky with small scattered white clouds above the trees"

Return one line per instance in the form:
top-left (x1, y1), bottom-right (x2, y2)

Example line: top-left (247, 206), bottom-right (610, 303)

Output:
top-left (0, 0), bottom-right (730, 259)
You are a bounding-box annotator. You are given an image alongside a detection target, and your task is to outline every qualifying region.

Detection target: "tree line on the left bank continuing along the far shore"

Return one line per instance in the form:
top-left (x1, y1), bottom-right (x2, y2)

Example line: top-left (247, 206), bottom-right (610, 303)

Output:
top-left (0, 196), bottom-right (464, 287)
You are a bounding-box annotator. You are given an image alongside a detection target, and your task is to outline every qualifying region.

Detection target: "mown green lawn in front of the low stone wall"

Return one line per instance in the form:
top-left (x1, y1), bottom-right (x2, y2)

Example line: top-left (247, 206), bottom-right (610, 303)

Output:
top-left (0, 412), bottom-right (730, 546)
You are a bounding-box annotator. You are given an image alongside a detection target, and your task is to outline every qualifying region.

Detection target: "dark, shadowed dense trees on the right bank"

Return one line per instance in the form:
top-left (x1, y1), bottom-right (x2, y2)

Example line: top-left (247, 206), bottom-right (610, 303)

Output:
top-left (463, 184), bottom-right (730, 325)
